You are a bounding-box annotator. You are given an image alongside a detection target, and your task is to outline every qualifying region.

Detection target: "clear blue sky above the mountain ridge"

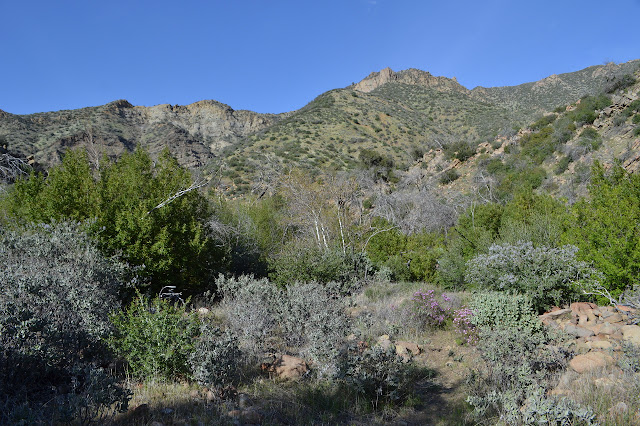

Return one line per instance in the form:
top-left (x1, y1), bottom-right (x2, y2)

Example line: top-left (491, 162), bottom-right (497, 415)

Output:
top-left (0, 0), bottom-right (640, 114)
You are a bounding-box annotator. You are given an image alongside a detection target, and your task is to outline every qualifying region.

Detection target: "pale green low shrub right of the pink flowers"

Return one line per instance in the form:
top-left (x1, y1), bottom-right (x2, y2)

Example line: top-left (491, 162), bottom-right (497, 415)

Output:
top-left (469, 292), bottom-right (542, 334)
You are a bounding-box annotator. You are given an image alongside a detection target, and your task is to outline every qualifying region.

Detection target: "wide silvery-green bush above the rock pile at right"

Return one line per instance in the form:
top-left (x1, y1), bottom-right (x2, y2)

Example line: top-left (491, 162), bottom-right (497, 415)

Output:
top-left (465, 242), bottom-right (597, 312)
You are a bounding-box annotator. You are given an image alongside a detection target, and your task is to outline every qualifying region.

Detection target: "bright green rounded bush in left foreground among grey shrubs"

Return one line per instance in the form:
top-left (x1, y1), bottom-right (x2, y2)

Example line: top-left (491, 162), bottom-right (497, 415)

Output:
top-left (109, 294), bottom-right (200, 380)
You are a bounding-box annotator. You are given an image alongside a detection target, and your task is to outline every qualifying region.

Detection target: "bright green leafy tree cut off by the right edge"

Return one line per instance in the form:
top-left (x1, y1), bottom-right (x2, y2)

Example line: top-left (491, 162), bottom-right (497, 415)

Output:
top-left (564, 162), bottom-right (640, 296)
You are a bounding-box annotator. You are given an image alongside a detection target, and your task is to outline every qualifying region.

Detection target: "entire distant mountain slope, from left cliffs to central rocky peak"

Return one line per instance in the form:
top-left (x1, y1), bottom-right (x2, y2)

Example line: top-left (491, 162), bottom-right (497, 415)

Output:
top-left (0, 60), bottom-right (640, 191)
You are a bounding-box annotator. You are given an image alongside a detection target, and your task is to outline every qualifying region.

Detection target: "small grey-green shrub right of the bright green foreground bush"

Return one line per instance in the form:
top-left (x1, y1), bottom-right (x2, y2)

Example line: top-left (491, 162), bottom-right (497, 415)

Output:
top-left (189, 324), bottom-right (241, 387)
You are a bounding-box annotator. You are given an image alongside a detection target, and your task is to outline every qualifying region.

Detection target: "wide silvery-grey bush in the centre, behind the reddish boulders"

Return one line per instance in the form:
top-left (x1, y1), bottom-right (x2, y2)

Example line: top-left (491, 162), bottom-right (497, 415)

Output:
top-left (216, 277), bottom-right (350, 376)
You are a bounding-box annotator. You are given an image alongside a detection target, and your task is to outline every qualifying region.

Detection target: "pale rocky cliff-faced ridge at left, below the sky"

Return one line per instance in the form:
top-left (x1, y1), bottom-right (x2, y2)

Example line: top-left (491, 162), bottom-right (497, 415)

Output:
top-left (0, 100), bottom-right (280, 167)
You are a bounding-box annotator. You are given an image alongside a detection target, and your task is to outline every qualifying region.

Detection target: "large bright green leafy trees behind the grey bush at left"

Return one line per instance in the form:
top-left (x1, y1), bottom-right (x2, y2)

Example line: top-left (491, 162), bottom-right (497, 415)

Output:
top-left (6, 150), bottom-right (215, 289)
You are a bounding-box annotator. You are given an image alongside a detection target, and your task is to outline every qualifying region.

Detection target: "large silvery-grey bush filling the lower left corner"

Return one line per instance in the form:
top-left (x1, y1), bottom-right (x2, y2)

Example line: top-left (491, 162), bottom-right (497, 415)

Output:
top-left (0, 223), bottom-right (130, 424)
